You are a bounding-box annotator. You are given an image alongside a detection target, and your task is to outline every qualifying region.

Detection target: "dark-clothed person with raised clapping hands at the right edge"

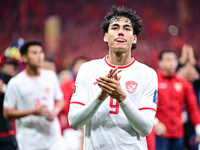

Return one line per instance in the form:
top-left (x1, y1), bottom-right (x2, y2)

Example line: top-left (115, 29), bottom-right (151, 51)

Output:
top-left (178, 45), bottom-right (200, 150)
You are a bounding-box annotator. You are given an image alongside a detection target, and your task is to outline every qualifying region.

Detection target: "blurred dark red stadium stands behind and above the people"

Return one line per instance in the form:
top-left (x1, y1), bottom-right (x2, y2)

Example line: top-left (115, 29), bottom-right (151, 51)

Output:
top-left (0, 0), bottom-right (200, 70)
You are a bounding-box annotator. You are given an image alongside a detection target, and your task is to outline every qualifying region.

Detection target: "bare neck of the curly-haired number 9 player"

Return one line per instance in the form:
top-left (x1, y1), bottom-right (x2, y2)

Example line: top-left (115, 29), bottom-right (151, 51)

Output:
top-left (108, 51), bottom-right (131, 66)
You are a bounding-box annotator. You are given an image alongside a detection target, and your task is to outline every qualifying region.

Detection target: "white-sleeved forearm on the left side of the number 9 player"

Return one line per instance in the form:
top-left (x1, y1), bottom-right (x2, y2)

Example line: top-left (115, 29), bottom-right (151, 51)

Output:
top-left (69, 98), bottom-right (102, 130)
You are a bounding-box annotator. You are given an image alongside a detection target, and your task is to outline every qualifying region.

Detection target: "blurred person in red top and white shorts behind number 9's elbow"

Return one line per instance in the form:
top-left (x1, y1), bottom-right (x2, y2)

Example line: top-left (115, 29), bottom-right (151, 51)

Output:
top-left (59, 57), bottom-right (87, 150)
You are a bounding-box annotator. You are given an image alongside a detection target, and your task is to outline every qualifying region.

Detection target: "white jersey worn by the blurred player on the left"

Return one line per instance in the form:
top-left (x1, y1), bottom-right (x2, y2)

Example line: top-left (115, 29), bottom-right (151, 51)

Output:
top-left (4, 69), bottom-right (63, 150)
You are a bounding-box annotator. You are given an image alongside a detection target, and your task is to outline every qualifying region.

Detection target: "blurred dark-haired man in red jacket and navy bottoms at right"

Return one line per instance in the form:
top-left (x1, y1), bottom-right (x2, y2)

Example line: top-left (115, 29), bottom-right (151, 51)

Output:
top-left (154, 50), bottom-right (200, 150)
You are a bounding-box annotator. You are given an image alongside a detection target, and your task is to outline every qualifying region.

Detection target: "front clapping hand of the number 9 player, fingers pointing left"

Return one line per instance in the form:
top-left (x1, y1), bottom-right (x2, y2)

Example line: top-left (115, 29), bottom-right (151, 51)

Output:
top-left (96, 70), bottom-right (126, 102)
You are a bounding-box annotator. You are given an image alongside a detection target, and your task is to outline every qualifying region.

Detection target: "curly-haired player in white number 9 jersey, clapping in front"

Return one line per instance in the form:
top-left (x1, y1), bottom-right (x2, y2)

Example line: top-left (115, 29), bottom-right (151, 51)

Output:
top-left (69, 6), bottom-right (157, 150)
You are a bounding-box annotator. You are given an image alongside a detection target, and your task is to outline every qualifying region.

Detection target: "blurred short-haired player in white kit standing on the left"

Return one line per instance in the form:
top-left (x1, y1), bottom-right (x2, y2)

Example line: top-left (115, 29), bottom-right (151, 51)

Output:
top-left (4, 40), bottom-right (64, 150)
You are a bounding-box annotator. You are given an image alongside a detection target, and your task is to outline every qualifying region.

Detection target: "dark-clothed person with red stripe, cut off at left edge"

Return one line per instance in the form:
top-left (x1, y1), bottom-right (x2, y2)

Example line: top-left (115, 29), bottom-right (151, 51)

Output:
top-left (0, 72), bottom-right (18, 150)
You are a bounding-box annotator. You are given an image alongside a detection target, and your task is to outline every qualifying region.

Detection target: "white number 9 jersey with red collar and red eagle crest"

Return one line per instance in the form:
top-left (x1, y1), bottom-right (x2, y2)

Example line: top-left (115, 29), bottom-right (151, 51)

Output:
top-left (70, 57), bottom-right (158, 150)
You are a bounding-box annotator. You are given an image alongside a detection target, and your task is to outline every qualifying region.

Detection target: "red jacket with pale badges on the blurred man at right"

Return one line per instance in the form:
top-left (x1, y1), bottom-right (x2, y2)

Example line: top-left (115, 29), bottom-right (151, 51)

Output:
top-left (156, 70), bottom-right (200, 138)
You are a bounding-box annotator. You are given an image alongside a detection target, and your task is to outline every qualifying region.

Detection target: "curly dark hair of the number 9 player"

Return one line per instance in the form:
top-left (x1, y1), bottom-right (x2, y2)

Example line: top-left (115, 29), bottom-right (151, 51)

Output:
top-left (101, 6), bottom-right (143, 49)
